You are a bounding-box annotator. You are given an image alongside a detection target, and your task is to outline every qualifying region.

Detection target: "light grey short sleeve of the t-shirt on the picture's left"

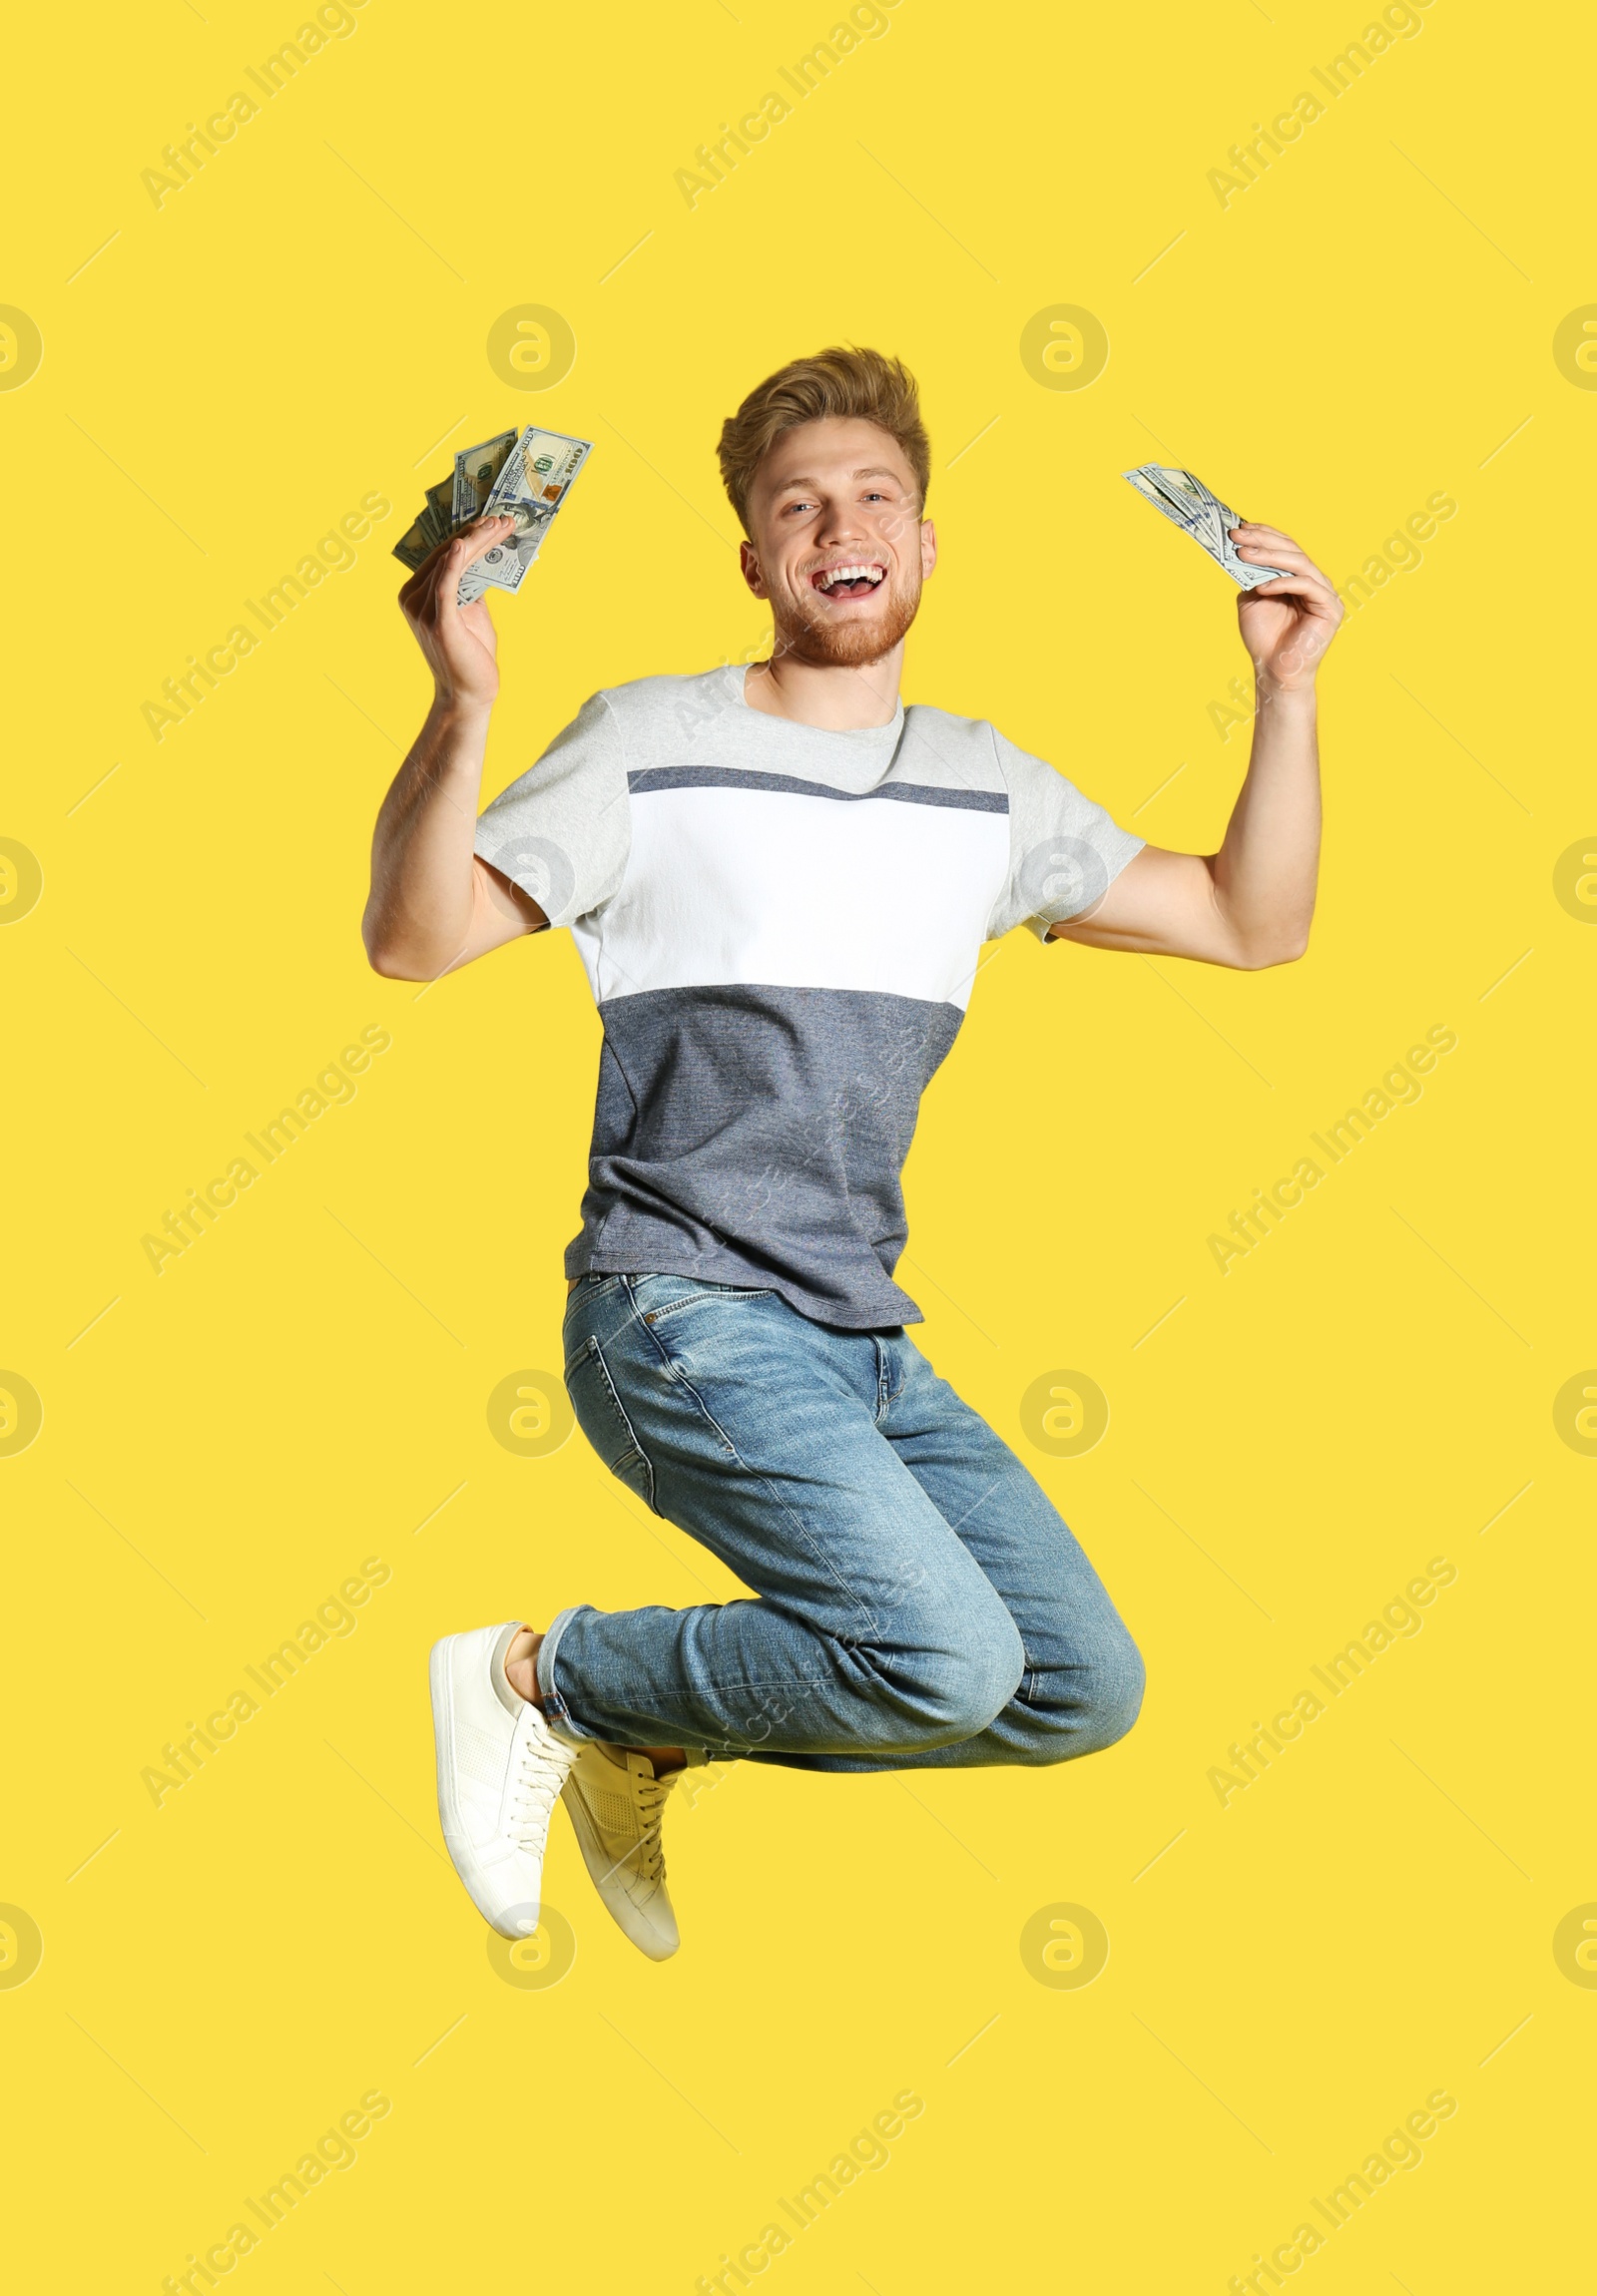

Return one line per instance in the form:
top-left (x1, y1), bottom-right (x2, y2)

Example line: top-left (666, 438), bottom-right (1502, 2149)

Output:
top-left (476, 693), bottom-right (632, 925)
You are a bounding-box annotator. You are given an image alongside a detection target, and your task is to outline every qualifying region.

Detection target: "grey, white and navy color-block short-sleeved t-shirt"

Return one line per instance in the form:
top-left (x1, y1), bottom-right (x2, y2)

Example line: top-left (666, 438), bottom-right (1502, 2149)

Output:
top-left (476, 669), bottom-right (1142, 1329)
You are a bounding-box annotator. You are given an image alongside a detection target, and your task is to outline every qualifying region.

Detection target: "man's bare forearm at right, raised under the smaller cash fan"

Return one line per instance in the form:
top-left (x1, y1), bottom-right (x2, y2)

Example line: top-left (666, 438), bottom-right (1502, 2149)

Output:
top-left (1209, 687), bottom-right (1319, 964)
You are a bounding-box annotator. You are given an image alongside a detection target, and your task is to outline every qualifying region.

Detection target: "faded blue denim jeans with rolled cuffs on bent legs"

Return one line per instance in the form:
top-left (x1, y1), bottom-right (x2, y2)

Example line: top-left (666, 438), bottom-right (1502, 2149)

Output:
top-left (538, 1274), bottom-right (1142, 1770)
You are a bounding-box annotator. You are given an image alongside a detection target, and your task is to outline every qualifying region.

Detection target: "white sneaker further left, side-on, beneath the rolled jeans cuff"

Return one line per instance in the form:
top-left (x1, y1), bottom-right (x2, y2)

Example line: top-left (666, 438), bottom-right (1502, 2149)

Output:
top-left (432, 1618), bottom-right (577, 1938)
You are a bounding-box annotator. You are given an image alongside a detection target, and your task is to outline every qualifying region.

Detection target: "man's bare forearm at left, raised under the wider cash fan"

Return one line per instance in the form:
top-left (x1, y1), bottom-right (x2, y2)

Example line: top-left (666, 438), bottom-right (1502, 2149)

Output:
top-left (360, 698), bottom-right (489, 981)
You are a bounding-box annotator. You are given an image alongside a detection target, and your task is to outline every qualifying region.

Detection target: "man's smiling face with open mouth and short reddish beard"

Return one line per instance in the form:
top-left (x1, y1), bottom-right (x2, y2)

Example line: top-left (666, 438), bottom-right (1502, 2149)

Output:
top-left (743, 415), bottom-right (937, 669)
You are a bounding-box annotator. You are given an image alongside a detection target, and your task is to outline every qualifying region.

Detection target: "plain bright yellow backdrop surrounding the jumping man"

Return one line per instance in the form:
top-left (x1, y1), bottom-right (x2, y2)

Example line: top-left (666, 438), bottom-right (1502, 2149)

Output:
top-left (0, 0), bottom-right (1597, 2296)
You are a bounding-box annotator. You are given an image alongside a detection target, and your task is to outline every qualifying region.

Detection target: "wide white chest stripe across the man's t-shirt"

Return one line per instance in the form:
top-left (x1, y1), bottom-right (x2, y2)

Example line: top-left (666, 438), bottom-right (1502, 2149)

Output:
top-left (572, 769), bottom-right (1009, 1010)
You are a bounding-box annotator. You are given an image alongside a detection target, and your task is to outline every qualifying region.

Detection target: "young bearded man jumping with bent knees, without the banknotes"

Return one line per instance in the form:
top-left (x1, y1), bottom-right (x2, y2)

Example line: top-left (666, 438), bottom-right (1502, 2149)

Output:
top-left (363, 349), bottom-right (1341, 1959)
